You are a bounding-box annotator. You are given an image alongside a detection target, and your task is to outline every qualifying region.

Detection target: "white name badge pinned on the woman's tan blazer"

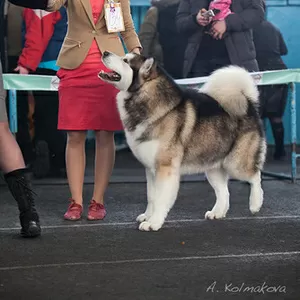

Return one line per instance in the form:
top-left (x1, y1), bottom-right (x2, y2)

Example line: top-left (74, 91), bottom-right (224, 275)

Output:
top-left (104, 0), bottom-right (125, 33)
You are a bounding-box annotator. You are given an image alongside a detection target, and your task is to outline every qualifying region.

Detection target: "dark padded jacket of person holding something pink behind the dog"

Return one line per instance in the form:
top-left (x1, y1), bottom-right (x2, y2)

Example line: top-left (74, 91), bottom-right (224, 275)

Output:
top-left (176, 0), bottom-right (264, 77)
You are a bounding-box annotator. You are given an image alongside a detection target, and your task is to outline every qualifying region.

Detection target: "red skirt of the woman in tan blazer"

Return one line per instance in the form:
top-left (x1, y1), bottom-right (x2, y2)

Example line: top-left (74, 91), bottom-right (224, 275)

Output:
top-left (57, 60), bottom-right (123, 131)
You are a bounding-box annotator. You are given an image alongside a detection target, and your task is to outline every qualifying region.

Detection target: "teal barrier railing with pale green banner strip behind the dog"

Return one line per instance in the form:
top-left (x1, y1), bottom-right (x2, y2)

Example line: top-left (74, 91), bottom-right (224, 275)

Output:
top-left (3, 69), bottom-right (300, 182)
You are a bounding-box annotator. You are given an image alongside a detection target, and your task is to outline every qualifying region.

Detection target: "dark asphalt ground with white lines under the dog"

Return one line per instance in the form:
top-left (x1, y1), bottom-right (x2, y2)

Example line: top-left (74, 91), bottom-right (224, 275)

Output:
top-left (0, 151), bottom-right (300, 300)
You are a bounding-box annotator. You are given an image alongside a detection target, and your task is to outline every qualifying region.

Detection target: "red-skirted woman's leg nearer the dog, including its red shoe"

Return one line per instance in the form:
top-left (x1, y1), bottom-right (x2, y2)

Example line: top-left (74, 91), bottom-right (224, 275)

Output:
top-left (88, 131), bottom-right (115, 220)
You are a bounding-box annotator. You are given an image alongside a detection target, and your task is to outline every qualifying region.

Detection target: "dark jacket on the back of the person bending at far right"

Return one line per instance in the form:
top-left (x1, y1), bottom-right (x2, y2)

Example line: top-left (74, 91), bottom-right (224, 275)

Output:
top-left (253, 20), bottom-right (288, 71)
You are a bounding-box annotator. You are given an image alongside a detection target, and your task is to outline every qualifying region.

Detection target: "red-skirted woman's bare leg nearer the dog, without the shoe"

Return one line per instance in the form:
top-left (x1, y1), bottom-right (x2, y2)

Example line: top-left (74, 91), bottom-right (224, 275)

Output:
top-left (93, 131), bottom-right (115, 204)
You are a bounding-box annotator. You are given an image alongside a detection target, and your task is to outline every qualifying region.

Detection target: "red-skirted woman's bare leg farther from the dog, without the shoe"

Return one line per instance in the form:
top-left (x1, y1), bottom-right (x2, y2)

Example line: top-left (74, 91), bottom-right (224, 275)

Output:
top-left (66, 131), bottom-right (86, 205)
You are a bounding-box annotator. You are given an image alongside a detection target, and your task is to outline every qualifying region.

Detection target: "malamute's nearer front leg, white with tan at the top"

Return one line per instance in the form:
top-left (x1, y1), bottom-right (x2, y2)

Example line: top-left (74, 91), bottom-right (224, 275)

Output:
top-left (139, 166), bottom-right (180, 231)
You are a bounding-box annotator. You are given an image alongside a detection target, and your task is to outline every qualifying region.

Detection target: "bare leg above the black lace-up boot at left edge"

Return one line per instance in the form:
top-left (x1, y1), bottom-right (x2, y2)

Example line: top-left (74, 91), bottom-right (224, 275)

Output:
top-left (0, 122), bottom-right (25, 174)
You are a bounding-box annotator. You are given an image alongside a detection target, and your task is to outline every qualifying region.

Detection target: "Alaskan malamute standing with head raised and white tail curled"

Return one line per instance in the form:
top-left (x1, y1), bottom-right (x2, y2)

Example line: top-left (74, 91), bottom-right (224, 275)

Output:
top-left (99, 52), bottom-right (266, 231)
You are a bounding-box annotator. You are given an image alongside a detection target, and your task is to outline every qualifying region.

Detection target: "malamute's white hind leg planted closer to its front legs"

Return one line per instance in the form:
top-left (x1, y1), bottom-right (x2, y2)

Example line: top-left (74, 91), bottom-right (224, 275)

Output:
top-left (205, 168), bottom-right (229, 220)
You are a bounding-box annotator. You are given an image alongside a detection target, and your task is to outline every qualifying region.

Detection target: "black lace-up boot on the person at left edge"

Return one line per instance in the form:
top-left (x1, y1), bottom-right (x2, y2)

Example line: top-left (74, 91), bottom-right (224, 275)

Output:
top-left (4, 169), bottom-right (41, 237)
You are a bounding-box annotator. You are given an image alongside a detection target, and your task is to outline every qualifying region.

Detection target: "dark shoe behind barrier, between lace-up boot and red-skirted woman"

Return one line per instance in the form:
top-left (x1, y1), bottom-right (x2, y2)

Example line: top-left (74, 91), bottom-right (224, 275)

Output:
top-left (32, 141), bottom-right (50, 179)
